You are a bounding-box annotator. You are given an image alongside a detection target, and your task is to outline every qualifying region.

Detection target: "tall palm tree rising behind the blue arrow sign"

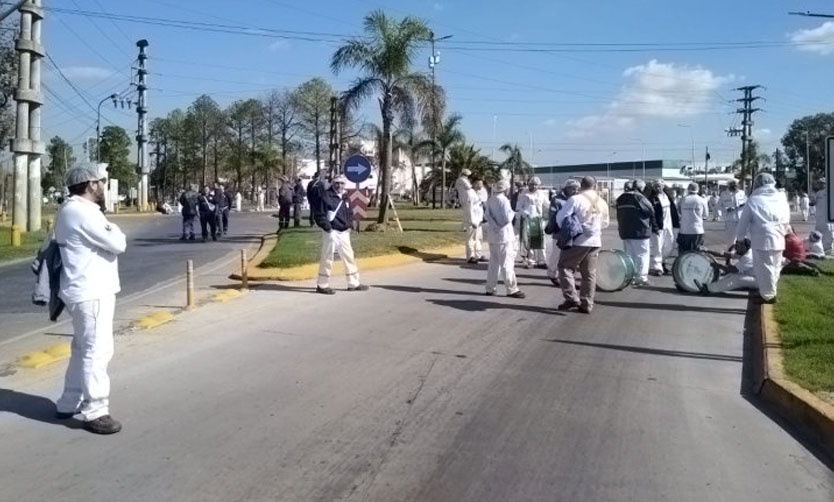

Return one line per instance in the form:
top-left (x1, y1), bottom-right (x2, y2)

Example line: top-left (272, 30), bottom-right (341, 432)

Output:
top-left (330, 10), bottom-right (436, 223)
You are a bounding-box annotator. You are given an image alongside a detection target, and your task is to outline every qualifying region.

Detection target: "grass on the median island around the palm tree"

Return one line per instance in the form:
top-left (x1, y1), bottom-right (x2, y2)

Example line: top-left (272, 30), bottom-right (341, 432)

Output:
top-left (259, 207), bottom-right (466, 268)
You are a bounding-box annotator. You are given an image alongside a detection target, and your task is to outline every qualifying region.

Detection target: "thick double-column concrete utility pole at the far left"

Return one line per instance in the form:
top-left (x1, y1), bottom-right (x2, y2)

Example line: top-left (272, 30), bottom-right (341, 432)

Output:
top-left (11, 0), bottom-right (46, 232)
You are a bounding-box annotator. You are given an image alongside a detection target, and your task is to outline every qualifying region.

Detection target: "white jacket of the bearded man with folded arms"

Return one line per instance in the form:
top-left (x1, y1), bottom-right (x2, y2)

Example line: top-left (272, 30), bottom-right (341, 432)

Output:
top-left (55, 196), bottom-right (127, 303)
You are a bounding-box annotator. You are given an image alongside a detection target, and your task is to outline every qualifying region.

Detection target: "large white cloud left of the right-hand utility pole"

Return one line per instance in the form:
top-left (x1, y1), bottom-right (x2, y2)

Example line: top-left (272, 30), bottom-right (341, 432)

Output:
top-left (569, 59), bottom-right (735, 137)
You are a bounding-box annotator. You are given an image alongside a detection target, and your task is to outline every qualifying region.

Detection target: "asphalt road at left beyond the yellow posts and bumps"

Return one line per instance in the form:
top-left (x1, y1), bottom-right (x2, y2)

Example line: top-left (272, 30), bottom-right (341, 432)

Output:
top-left (0, 208), bottom-right (278, 344)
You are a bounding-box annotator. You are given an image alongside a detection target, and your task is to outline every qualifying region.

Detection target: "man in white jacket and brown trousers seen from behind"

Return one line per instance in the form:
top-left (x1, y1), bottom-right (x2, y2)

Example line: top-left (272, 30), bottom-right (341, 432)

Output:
top-left (556, 176), bottom-right (609, 314)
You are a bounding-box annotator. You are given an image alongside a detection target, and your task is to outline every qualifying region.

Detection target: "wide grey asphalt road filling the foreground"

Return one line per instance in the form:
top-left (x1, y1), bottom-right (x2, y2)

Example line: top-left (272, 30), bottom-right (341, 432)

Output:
top-left (0, 220), bottom-right (834, 502)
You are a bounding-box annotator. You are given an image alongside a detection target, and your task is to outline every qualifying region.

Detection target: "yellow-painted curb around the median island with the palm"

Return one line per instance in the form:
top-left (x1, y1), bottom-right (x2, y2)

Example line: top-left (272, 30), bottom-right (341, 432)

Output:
top-left (229, 234), bottom-right (464, 281)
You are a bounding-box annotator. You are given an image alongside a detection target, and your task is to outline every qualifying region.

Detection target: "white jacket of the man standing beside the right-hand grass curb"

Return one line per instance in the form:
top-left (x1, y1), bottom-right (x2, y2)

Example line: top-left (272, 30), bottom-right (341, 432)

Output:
top-left (736, 185), bottom-right (791, 251)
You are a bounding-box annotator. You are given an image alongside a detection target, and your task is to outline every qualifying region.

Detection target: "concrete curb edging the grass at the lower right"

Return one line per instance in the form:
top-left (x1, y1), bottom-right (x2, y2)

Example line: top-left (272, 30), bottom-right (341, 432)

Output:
top-left (755, 305), bottom-right (834, 458)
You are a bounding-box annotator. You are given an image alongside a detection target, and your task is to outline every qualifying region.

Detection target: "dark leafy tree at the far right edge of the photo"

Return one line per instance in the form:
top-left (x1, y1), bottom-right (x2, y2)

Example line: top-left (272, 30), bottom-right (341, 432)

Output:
top-left (782, 113), bottom-right (834, 187)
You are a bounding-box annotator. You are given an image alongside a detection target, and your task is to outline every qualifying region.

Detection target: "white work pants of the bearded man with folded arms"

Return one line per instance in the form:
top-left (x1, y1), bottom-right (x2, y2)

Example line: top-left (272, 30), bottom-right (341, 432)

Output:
top-left (56, 295), bottom-right (116, 422)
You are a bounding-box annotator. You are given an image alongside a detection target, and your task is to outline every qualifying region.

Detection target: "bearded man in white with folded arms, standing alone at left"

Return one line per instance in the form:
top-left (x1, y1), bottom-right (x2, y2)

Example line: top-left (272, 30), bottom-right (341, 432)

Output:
top-left (55, 162), bottom-right (127, 434)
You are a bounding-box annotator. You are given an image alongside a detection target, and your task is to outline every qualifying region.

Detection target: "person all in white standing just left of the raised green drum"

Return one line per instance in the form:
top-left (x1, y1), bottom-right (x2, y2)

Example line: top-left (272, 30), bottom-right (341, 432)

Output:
top-left (486, 179), bottom-right (525, 298)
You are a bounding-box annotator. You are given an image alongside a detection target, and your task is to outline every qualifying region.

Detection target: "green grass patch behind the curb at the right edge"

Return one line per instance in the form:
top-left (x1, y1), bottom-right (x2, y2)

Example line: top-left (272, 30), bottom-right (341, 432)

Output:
top-left (774, 260), bottom-right (834, 392)
